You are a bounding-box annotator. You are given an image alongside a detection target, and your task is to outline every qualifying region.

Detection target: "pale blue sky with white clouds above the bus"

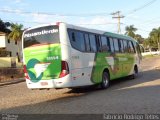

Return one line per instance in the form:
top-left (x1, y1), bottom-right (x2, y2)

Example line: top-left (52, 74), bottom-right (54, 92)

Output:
top-left (0, 0), bottom-right (160, 38)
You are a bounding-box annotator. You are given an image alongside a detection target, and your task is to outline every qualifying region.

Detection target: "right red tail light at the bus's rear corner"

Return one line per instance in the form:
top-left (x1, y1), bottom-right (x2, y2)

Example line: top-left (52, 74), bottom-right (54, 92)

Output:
top-left (59, 61), bottom-right (69, 78)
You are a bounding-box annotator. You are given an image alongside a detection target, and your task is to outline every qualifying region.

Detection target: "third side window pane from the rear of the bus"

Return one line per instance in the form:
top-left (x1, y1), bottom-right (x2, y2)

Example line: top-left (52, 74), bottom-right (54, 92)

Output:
top-left (89, 34), bottom-right (97, 52)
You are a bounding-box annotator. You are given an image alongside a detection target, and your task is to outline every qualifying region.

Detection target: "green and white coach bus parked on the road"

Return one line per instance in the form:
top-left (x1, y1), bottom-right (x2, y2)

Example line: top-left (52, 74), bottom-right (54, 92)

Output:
top-left (22, 22), bottom-right (141, 89)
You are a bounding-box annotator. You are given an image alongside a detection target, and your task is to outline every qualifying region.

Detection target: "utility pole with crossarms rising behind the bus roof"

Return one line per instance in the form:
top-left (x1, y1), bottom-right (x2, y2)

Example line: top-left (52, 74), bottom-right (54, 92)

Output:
top-left (111, 11), bottom-right (124, 33)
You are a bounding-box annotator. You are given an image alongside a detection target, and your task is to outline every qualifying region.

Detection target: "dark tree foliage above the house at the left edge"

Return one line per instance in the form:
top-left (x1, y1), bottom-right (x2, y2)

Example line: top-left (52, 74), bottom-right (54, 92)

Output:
top-left (0, 19), bottom-right (11, 34)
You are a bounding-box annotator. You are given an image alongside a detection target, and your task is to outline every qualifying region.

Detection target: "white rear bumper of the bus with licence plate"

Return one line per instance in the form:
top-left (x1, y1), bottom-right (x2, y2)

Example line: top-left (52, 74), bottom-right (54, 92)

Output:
top-left (26, 75), bottom-right (72, 89)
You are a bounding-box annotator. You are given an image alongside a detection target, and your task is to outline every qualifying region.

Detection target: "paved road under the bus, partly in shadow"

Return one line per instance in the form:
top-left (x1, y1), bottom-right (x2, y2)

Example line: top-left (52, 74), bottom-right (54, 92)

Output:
top-left (0, 57), bottom-right (160, 114)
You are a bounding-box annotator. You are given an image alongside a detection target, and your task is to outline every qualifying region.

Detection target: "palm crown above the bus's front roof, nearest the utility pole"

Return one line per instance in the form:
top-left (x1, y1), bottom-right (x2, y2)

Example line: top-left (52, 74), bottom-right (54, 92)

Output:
top-left (125, 25), bottom-right (137, 38)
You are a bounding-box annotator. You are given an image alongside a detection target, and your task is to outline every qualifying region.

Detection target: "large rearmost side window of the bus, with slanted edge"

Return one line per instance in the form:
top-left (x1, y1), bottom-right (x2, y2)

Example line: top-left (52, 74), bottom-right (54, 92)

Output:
top-left (69, 30), bottom-right (85, 51)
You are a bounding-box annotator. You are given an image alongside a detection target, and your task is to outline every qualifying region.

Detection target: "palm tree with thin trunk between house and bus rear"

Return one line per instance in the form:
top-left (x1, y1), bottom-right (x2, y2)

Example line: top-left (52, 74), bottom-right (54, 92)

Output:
top-left (8, 23), bottom-right (23, 61)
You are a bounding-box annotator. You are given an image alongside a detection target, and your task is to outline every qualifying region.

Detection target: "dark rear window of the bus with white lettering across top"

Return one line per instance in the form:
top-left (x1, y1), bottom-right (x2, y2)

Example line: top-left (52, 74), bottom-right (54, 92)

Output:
top-left (23, 26), bottom-right (59, 48)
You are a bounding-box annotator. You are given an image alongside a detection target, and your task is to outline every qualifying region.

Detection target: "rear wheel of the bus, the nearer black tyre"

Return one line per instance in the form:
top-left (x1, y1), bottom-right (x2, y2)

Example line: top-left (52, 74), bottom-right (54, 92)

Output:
top-left (101, 71), bottom-right (109, 89)
